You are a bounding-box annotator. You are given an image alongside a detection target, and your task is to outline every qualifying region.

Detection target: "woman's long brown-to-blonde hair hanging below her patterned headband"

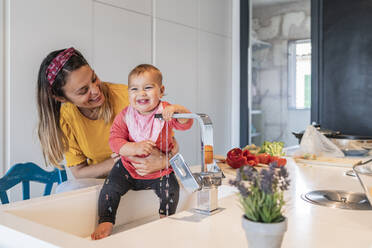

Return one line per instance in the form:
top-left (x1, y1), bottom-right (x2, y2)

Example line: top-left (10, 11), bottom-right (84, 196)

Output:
top-left (37, 50), bottom-right (114, 168)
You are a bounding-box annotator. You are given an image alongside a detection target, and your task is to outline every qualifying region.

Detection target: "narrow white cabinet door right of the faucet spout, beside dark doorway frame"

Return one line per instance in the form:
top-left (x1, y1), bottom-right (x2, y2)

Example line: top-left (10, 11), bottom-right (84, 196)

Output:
top-left (198, 32), bottom-right (232, 154)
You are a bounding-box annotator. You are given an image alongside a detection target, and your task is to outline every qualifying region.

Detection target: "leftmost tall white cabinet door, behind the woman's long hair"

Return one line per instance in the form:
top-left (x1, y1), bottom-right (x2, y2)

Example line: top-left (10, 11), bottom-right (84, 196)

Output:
top-left (5, 0), bottom-right (92, 167)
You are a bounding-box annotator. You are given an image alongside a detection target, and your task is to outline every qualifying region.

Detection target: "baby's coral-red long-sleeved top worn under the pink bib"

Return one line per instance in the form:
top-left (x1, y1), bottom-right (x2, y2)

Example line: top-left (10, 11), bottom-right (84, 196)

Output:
top-left (109, 102), bottom-right (193, 179)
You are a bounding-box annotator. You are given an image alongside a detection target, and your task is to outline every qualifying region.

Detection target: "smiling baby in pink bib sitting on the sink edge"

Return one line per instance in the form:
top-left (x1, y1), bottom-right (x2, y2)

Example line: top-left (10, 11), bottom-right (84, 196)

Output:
top-left (91, 64), bottom-right (193, 239)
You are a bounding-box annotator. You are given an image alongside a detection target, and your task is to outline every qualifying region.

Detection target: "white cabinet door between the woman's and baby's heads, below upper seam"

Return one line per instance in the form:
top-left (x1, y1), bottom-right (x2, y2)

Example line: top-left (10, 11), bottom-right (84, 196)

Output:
top-left (93, 2), bottom-right (152, 84)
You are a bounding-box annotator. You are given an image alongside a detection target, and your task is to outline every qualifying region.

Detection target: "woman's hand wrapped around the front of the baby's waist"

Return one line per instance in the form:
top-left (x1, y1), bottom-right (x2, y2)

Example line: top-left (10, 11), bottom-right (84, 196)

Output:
top-left (129, 137), bottom-right (179, 175)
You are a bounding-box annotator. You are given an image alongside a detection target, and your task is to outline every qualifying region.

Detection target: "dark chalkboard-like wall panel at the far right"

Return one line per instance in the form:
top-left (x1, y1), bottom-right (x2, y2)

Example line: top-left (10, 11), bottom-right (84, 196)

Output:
top-left (313, 0), bottom-right (372, 136)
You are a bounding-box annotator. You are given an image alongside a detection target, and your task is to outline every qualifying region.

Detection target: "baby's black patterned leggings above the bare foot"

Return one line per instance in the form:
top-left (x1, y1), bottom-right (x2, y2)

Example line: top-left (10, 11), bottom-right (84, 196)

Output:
top-left (98, 160), bottom-right (180, 224)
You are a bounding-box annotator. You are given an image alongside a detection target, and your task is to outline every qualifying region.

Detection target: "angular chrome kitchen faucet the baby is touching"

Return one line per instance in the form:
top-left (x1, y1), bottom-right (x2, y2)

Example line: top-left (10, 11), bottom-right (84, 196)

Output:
top-left (155, 113), bottom-right (224, 215)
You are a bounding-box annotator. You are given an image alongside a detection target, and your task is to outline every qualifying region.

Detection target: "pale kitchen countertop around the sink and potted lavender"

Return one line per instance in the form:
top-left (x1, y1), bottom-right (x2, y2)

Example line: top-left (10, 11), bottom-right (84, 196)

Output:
top-left (0, 158), bottom-right (372, 248)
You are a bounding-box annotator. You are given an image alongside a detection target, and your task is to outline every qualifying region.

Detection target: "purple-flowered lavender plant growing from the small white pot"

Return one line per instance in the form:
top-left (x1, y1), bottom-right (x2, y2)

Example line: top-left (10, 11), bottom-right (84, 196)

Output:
top-left (229, 162), bottom-right (290, 223)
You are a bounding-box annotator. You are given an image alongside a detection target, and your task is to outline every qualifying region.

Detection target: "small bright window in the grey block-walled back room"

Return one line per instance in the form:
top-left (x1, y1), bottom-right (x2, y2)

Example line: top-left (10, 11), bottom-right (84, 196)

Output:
top-left (288, 40), bottom-right (311, 109)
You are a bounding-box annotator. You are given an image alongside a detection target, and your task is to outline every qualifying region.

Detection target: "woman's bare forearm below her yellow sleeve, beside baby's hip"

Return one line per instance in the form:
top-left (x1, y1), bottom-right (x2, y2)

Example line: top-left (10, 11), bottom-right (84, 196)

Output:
top-left (70, 158), bottom-right (116, 178)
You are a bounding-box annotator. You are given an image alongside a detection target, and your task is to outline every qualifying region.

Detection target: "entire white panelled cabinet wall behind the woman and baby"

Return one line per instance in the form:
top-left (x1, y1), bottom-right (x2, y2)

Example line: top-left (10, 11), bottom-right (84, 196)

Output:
top-left (0, 0), bottom-right (239, 201)
